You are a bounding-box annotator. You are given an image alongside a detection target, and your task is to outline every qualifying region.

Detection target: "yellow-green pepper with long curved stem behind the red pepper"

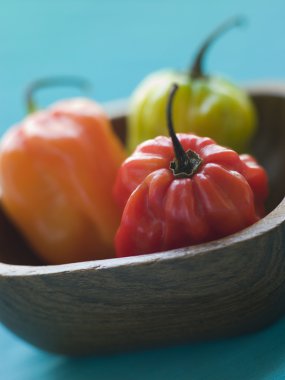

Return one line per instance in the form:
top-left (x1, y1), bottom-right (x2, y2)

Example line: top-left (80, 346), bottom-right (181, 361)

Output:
top-left (127, 18), bottom-right (256, 152)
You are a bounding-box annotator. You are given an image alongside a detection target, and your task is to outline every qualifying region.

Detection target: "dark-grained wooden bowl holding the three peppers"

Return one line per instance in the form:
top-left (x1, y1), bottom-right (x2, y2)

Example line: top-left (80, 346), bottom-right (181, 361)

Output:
top-left (0, 86), bottom-right (285, 354)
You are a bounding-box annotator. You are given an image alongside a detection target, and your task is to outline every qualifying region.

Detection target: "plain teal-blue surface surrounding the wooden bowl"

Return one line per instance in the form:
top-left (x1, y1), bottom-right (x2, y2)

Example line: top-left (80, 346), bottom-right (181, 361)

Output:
top-left (0, 0), bottom-right (285, 380)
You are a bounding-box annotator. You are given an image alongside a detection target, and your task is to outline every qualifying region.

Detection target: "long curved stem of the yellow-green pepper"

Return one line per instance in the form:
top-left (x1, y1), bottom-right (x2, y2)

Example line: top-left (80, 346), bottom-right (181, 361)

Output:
top-left (189, 16), bottom-right (246, 79)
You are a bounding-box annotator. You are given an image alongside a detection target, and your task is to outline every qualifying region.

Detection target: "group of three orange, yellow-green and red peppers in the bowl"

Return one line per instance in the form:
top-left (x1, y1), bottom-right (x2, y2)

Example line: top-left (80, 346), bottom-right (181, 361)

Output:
top-left (0, 14), bottom-right (268, 264)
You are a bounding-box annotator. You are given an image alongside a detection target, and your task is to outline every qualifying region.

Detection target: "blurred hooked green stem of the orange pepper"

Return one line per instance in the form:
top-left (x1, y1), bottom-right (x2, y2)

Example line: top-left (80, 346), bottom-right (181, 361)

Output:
top-left (25, 76), bottom-right (91, 114)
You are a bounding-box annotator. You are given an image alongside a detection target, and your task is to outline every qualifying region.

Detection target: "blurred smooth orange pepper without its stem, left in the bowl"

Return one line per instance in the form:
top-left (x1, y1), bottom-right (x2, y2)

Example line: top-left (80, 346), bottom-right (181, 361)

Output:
top-left (0, 98), bottom-right (125, 264)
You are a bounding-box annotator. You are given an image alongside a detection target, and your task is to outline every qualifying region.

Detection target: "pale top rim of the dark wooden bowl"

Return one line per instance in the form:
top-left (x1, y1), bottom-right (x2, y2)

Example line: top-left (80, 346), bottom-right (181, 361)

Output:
top-left (0, 81), bottom-right (285, 279)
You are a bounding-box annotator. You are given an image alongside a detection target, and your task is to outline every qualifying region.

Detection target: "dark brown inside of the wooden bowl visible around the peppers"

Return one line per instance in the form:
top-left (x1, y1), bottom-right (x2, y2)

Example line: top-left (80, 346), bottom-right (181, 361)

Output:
top-left (0, 93), bottom-right (285, 265)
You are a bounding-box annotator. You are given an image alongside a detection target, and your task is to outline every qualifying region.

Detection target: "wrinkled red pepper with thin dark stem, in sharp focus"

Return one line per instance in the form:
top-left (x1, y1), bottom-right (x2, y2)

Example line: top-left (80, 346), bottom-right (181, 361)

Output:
top-left (114, 85), bottom-right (268, 257)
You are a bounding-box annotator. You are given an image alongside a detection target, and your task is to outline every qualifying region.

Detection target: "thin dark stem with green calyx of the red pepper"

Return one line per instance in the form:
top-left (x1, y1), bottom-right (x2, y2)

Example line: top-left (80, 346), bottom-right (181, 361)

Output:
top-left (166, 84), bottom-right (202, 178)
